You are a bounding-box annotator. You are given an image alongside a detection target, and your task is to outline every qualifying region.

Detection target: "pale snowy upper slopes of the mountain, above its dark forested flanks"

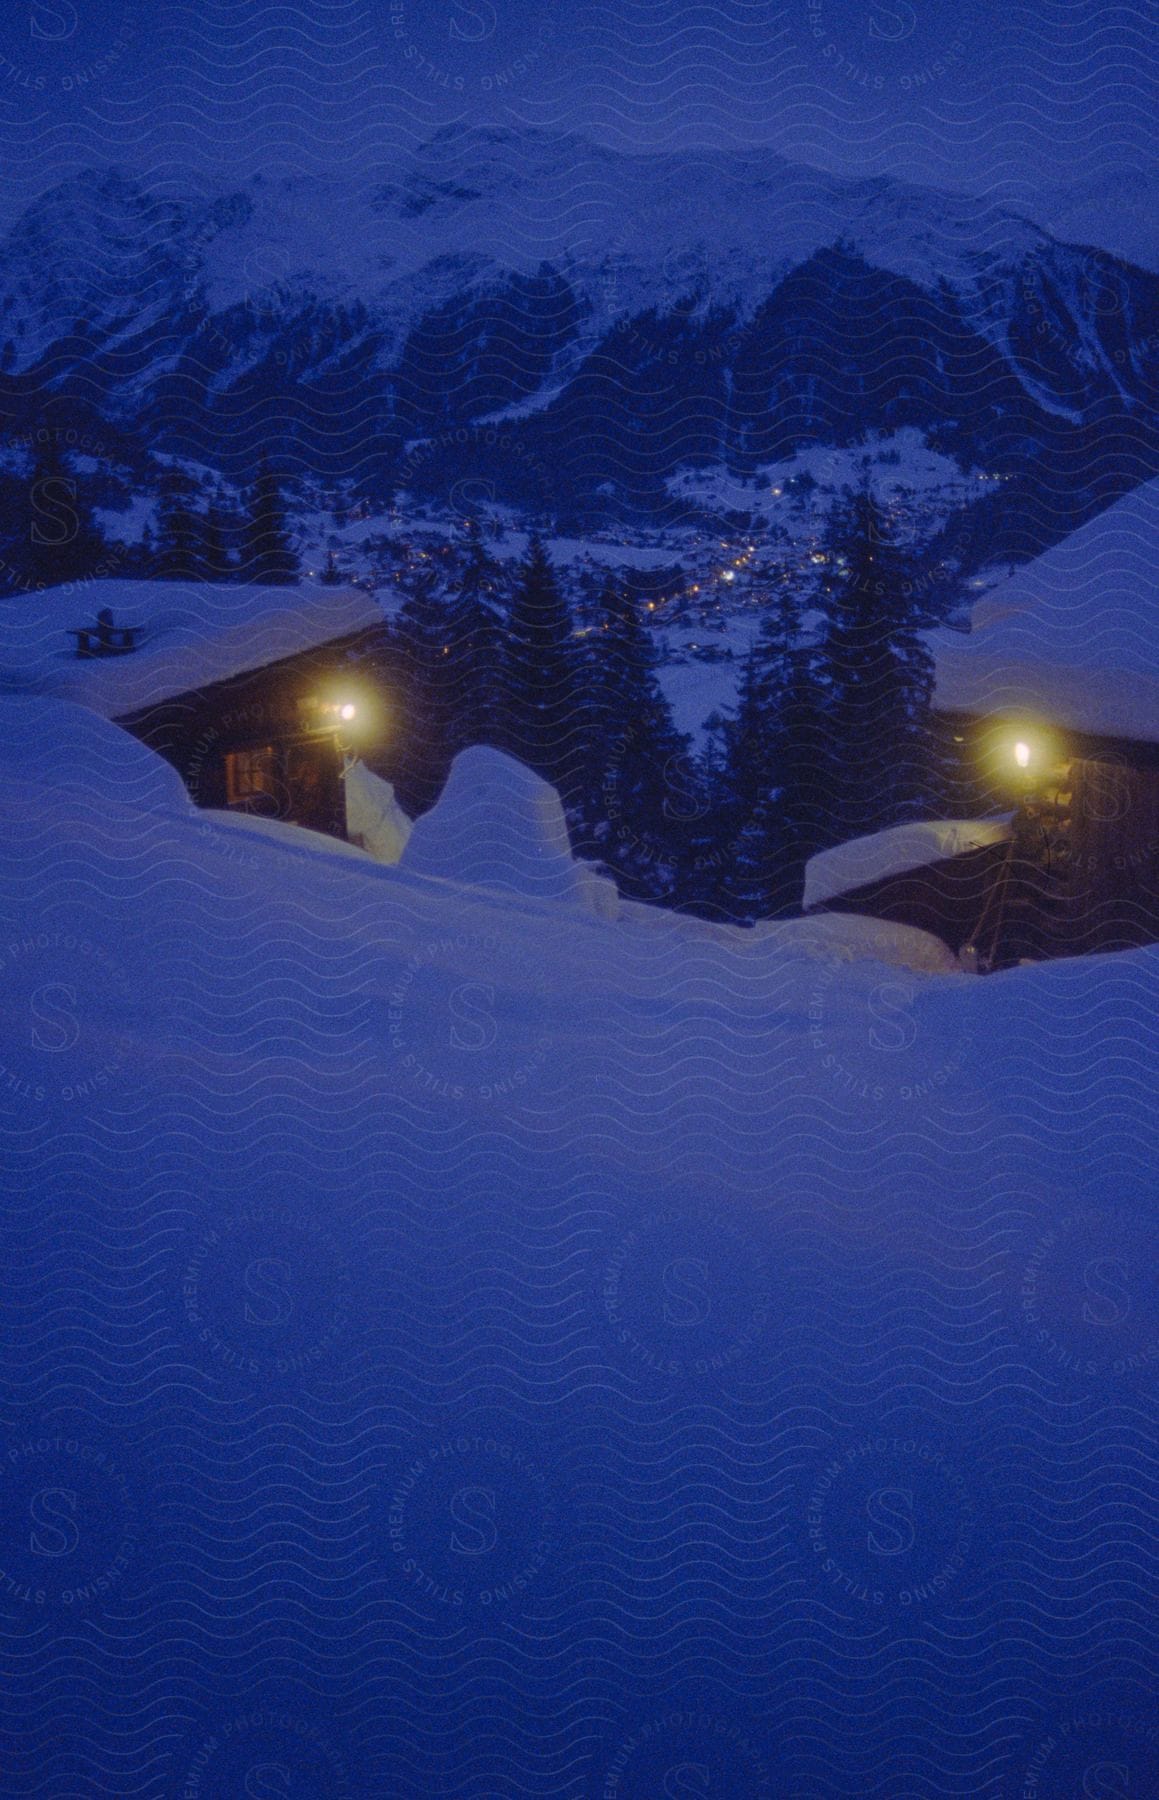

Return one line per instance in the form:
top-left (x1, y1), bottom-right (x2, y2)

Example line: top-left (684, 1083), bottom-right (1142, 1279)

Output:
top-left (0, 126), bottom-right (1044, 365)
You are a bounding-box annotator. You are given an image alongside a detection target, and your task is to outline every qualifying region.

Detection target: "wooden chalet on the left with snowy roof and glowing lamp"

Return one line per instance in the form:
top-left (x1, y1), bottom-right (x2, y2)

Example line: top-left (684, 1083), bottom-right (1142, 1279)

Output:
top-left (0, 581), bottom-right (389, 837)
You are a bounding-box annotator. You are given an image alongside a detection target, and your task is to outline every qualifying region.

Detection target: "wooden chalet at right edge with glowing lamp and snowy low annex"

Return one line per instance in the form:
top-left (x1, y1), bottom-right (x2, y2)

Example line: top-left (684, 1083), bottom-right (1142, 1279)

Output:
top-left (806, 482), bottom-right (1159, 968)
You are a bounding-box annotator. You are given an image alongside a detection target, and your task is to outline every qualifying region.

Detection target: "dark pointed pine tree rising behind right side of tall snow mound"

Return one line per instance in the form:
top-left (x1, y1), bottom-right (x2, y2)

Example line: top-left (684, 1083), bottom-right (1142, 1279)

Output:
top-left (500, 536), bottom-right (585, 805)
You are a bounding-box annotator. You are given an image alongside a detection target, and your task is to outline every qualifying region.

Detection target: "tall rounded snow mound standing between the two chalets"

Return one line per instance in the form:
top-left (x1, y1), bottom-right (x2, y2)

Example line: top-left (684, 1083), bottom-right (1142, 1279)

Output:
top-left (403, 747), bottom-right (614, 918)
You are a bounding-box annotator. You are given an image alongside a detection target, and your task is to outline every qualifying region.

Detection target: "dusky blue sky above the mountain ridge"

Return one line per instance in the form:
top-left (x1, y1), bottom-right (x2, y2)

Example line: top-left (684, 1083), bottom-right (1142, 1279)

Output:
top-left (0, 0), bottom-right (1159, 214)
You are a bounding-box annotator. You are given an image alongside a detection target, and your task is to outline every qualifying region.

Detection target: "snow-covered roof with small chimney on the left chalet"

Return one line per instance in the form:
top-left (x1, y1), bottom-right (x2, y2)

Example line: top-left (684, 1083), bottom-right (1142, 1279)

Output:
top-left (0, 581), bottom-right (382, 718)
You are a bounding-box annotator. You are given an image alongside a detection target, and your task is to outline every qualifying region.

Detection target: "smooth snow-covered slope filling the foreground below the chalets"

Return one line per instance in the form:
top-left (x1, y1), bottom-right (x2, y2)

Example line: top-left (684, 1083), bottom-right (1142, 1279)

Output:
top-left (0, 698), bottom-right (1159, 1800)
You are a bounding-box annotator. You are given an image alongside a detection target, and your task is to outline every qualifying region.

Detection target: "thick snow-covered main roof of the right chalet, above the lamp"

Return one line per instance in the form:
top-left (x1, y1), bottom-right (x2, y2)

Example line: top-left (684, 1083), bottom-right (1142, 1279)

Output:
top-left (932, 481), bottom-right (1159, 743)
